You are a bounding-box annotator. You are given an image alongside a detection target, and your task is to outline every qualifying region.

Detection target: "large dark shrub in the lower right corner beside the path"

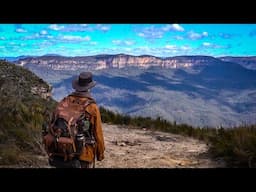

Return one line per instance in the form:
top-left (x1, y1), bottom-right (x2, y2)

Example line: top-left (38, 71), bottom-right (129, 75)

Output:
top-left (210, 126), bottom-right (256, 167)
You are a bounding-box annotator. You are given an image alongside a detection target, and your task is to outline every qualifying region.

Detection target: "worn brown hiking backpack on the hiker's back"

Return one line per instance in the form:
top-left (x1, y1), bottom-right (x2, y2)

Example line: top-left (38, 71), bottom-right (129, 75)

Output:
top-left (43, 97), bottom-right (95, 161)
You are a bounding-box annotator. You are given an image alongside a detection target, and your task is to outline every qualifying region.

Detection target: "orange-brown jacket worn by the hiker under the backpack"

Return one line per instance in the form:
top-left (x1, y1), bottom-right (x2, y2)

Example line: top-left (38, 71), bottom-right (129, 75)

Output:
top-left (68, 95), bottom-right (105, 162)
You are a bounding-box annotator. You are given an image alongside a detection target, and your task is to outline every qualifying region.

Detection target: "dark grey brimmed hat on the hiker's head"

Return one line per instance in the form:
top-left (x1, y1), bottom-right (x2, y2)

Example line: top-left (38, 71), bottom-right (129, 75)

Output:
top-left (72, 72), bottom-right (96, 91)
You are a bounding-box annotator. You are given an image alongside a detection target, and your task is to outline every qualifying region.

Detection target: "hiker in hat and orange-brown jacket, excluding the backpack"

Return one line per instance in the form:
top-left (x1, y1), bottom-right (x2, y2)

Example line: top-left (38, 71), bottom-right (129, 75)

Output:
top-left (44, 72), bottom-right (105, 168)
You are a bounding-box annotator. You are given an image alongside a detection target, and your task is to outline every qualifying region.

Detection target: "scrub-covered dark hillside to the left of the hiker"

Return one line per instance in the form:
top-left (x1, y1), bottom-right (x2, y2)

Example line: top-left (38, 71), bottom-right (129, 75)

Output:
top-left (0, 61), bottom-right (56, 165)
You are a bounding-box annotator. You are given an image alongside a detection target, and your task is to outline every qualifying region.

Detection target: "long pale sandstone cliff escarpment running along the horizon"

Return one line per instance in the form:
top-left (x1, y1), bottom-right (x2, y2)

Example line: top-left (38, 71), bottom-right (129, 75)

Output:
top-left (11, 54), bottom-right (256, 70)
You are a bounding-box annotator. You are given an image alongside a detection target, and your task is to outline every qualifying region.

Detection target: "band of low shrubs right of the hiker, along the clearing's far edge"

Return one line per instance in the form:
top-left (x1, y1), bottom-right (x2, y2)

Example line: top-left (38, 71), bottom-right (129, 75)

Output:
top-left (100, 107), bottom-right (256, 167)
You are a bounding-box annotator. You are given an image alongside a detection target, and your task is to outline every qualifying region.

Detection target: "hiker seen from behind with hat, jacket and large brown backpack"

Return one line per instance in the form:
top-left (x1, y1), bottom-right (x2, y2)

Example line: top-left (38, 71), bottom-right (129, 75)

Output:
top-left (43, 72), bottom-right (105, 168)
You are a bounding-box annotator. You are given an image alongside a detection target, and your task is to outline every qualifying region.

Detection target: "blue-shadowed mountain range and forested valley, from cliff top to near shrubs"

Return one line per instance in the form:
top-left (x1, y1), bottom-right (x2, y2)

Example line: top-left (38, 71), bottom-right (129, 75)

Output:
top-left (7, 54), bottom-right (256, 127)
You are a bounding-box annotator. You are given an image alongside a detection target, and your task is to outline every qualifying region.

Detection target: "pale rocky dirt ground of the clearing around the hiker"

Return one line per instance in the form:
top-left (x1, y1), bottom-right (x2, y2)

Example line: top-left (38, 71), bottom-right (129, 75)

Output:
top-left (0, 124), bottom-right (224, 168)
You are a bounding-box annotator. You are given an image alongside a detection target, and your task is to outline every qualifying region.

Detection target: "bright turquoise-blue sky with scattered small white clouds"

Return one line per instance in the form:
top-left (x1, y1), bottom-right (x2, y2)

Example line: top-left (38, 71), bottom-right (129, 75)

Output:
top-left (0, 24), bottom-right (256, 57)
